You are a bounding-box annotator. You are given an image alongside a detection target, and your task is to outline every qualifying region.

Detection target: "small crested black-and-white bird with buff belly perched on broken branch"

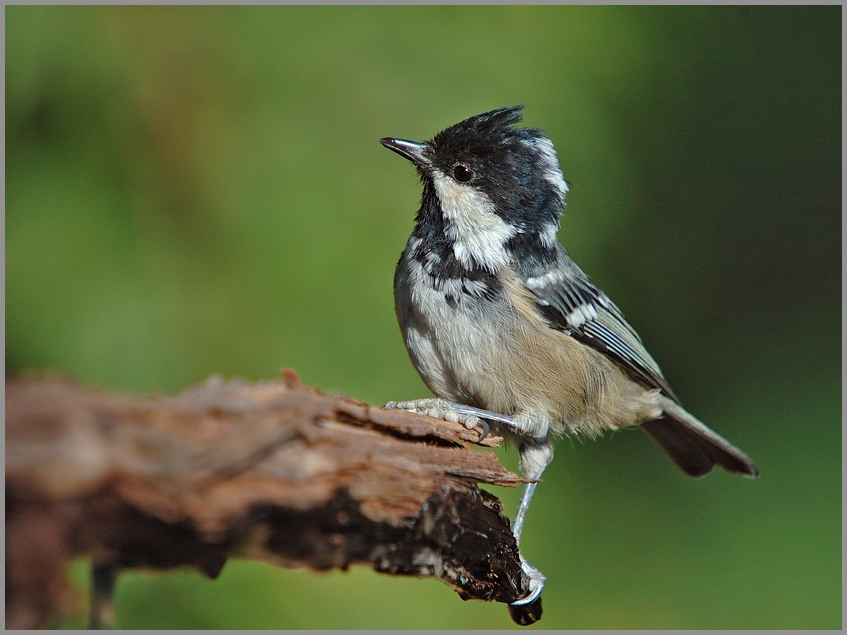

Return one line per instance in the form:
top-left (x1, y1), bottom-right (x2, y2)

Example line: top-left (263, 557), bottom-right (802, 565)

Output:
top-left (380, 106), bottom-right (759, 608)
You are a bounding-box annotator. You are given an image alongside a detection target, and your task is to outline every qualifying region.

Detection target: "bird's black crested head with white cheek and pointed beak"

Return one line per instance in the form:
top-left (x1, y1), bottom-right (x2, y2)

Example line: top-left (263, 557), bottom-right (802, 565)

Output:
top-left (380, 106), bottom-right (568, 270)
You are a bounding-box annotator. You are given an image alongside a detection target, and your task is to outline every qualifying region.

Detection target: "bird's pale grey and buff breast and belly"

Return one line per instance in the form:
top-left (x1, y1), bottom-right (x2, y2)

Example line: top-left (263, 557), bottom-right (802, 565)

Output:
top-left (395, 253), bottom-right (643, 433)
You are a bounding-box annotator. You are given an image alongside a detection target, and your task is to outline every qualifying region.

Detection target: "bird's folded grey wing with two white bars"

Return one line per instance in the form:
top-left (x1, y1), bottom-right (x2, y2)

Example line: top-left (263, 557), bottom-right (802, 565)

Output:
top-left (524, 254), bottom-right (678, 401)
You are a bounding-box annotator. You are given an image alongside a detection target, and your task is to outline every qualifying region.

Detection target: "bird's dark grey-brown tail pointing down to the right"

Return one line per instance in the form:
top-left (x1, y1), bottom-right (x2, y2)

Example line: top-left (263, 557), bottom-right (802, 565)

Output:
top-left (641, 396), bottom-right (759, 478)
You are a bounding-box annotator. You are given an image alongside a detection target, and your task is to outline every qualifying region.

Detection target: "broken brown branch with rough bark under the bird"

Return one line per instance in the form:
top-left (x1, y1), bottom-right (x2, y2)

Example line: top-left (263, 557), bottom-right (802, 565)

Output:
top-left (6, 371), bottom-right (540, 628)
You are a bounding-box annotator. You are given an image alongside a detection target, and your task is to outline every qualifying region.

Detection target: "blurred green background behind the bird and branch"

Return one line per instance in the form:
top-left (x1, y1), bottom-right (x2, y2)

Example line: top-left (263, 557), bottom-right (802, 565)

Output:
top-left (5, 6), bottom-right (841, 629)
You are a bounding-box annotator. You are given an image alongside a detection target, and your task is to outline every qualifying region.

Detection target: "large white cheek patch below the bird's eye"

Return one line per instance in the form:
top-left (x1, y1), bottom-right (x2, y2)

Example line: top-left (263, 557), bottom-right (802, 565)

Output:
top-left (432, 170), bottom-right (518, 273)
